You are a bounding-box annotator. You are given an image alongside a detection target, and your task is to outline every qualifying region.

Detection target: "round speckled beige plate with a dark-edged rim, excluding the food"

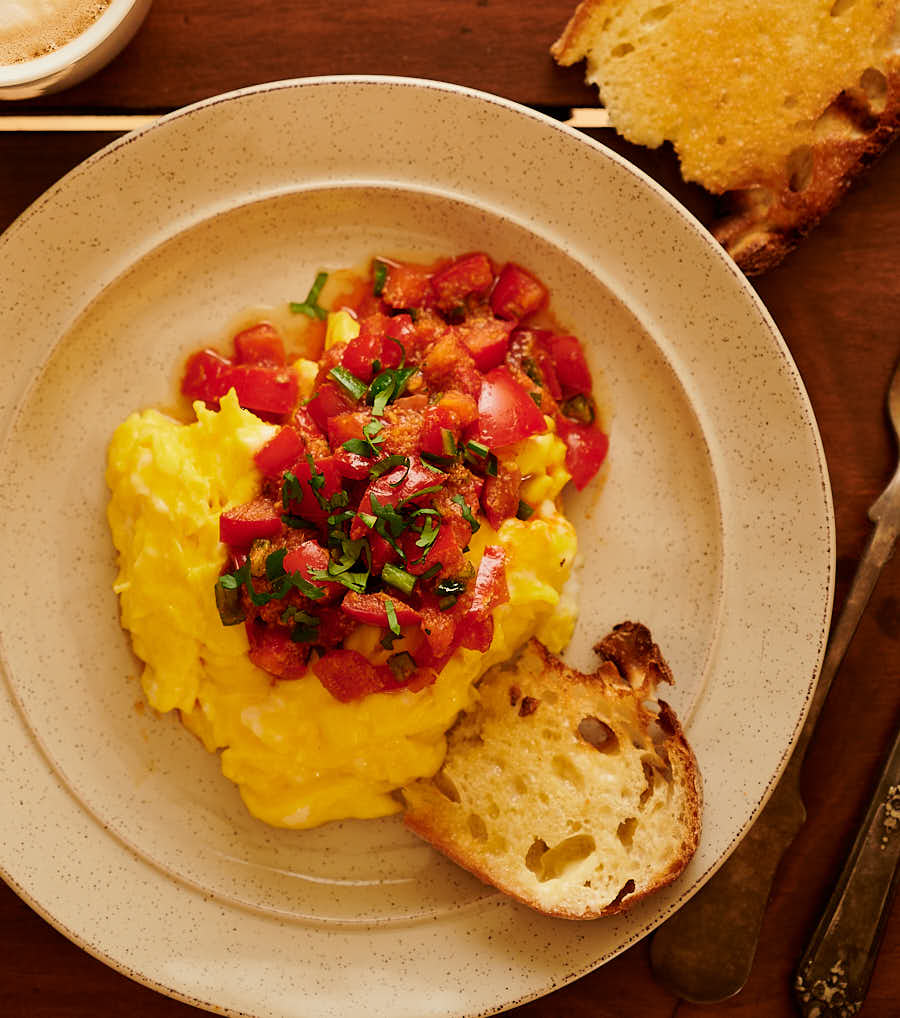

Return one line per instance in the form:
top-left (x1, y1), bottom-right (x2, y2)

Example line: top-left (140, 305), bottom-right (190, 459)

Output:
top-left (0, 78), bottom-right (834, 1018)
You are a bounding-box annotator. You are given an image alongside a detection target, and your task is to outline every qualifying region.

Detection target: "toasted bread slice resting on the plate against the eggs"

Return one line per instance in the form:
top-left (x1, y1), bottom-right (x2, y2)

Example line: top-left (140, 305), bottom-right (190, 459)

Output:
top-left (403, 622), bottom-right (701, 919)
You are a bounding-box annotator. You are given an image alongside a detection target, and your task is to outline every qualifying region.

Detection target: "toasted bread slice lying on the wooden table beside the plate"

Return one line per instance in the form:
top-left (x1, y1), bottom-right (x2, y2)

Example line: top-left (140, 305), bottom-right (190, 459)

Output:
top-left (551, 0), bottom-right (900, 274)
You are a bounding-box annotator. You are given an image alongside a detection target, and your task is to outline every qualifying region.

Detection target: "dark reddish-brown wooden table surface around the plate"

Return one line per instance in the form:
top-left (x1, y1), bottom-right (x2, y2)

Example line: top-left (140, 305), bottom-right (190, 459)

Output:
top-left (0, 0), bottom-right (900, 1018)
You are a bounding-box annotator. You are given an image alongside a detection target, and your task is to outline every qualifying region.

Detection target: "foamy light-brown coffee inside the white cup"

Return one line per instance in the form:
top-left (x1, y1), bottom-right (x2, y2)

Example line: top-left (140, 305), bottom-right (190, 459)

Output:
top-left (0, 0), bottom-right (110, 65)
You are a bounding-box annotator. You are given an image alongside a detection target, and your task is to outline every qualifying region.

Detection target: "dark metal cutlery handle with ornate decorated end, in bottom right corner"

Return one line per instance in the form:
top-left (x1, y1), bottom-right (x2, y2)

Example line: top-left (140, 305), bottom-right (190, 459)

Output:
top-left (794, 730), bottom-right (900, 1018)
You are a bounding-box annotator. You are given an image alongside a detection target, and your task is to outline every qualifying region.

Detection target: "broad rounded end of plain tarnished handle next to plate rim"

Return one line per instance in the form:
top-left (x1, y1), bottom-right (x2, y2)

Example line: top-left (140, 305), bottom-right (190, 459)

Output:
top-left (651, 754), bottom-right (806, 1004)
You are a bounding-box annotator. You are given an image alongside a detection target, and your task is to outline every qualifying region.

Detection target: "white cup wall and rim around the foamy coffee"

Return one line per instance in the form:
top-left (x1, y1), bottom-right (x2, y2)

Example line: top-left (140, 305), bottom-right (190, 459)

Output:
top-left (0, 0), bottom-right (151, 100)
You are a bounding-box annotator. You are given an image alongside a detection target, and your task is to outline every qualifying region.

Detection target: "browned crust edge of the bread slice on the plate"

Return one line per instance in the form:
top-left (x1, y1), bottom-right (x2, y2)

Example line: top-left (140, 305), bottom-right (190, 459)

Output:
top-left (403, 623), bottom-right (702, 920)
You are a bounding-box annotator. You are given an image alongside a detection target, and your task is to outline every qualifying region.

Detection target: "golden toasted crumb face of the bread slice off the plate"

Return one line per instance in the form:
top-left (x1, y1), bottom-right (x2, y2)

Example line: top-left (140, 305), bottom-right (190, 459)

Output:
top-left (553, 0), bottom-right (897, 193)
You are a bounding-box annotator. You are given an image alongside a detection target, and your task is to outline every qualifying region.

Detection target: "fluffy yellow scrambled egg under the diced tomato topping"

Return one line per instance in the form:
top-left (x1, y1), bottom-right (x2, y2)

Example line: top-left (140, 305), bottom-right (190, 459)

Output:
top-left (107, 392), bottom-right (575, 828)
